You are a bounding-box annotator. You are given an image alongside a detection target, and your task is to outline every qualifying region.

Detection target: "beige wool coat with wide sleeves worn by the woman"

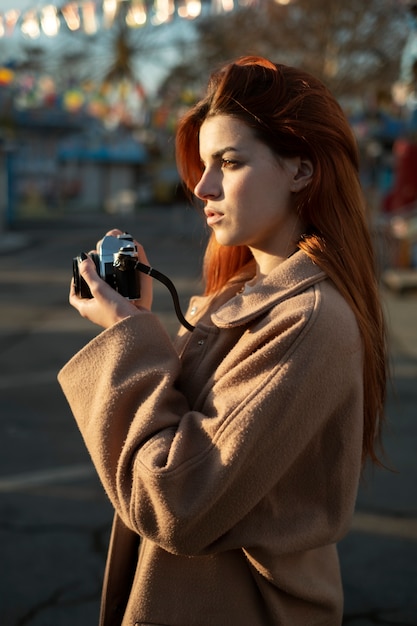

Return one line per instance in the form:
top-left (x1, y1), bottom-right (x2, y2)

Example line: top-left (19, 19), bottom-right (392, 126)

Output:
top-left (59, 251), bottom-right (363, 626)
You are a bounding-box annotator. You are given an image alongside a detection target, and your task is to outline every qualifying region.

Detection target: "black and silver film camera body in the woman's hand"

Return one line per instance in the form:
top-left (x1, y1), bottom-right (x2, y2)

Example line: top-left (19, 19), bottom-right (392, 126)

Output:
top-left (72, 233), bottom-right (140, 300)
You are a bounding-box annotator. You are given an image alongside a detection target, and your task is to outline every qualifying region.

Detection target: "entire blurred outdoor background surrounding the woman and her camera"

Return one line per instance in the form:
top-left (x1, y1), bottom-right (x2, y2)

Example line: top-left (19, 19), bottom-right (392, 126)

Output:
top-left (0, 0), bottom-right (417, 626)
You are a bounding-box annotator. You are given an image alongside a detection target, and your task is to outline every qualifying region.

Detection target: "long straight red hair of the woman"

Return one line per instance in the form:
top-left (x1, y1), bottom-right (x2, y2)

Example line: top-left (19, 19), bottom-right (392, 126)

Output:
top-left (176, 57), bottom-right (386, 462)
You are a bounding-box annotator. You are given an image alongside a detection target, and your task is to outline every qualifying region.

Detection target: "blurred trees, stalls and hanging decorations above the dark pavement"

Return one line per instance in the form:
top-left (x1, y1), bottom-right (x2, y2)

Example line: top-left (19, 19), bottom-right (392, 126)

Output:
top-left (0, 0), bottom-right (417, 234)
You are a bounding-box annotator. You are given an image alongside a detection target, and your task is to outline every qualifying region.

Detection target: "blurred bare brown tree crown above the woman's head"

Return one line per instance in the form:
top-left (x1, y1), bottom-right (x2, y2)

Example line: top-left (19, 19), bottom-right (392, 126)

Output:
top-left (161, 0), bottom-right (407, 97)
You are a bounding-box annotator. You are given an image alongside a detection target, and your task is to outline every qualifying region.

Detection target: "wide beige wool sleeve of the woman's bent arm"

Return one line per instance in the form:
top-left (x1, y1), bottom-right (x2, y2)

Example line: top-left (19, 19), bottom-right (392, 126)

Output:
top-left (59, 282), bottom-right (363, 555)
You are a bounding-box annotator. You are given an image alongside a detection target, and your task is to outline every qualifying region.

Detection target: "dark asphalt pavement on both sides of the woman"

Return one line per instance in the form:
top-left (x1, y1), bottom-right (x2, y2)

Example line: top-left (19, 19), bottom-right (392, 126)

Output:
top-left (0, 206), bottom-right (417, 626)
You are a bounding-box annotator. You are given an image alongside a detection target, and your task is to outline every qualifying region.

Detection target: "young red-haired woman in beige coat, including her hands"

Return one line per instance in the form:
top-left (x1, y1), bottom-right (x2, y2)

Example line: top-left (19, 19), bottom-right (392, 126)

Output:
top-left (59, 57), bottom-right (385, 626)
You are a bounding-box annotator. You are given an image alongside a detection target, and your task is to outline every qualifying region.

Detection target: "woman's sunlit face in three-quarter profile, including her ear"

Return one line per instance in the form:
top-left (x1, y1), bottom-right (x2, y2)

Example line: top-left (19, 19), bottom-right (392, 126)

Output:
top-left (194, 115), bottom-right (304, 257)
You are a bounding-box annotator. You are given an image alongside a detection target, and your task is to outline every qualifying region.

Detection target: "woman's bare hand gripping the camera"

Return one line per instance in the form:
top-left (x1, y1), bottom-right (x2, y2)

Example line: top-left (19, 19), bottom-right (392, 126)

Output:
top-left (69, 229), bottom-right (152, 328)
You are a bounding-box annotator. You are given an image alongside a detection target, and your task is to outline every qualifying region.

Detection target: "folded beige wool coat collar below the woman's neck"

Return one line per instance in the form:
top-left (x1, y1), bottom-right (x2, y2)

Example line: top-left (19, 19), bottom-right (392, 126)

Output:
top-left (211, 250), bottom-right (327, 328)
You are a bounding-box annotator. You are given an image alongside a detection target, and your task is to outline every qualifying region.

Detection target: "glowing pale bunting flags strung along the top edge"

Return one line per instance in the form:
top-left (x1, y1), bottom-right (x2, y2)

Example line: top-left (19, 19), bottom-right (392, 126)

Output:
top-left (0, 0), bottom-right (280, 39)
